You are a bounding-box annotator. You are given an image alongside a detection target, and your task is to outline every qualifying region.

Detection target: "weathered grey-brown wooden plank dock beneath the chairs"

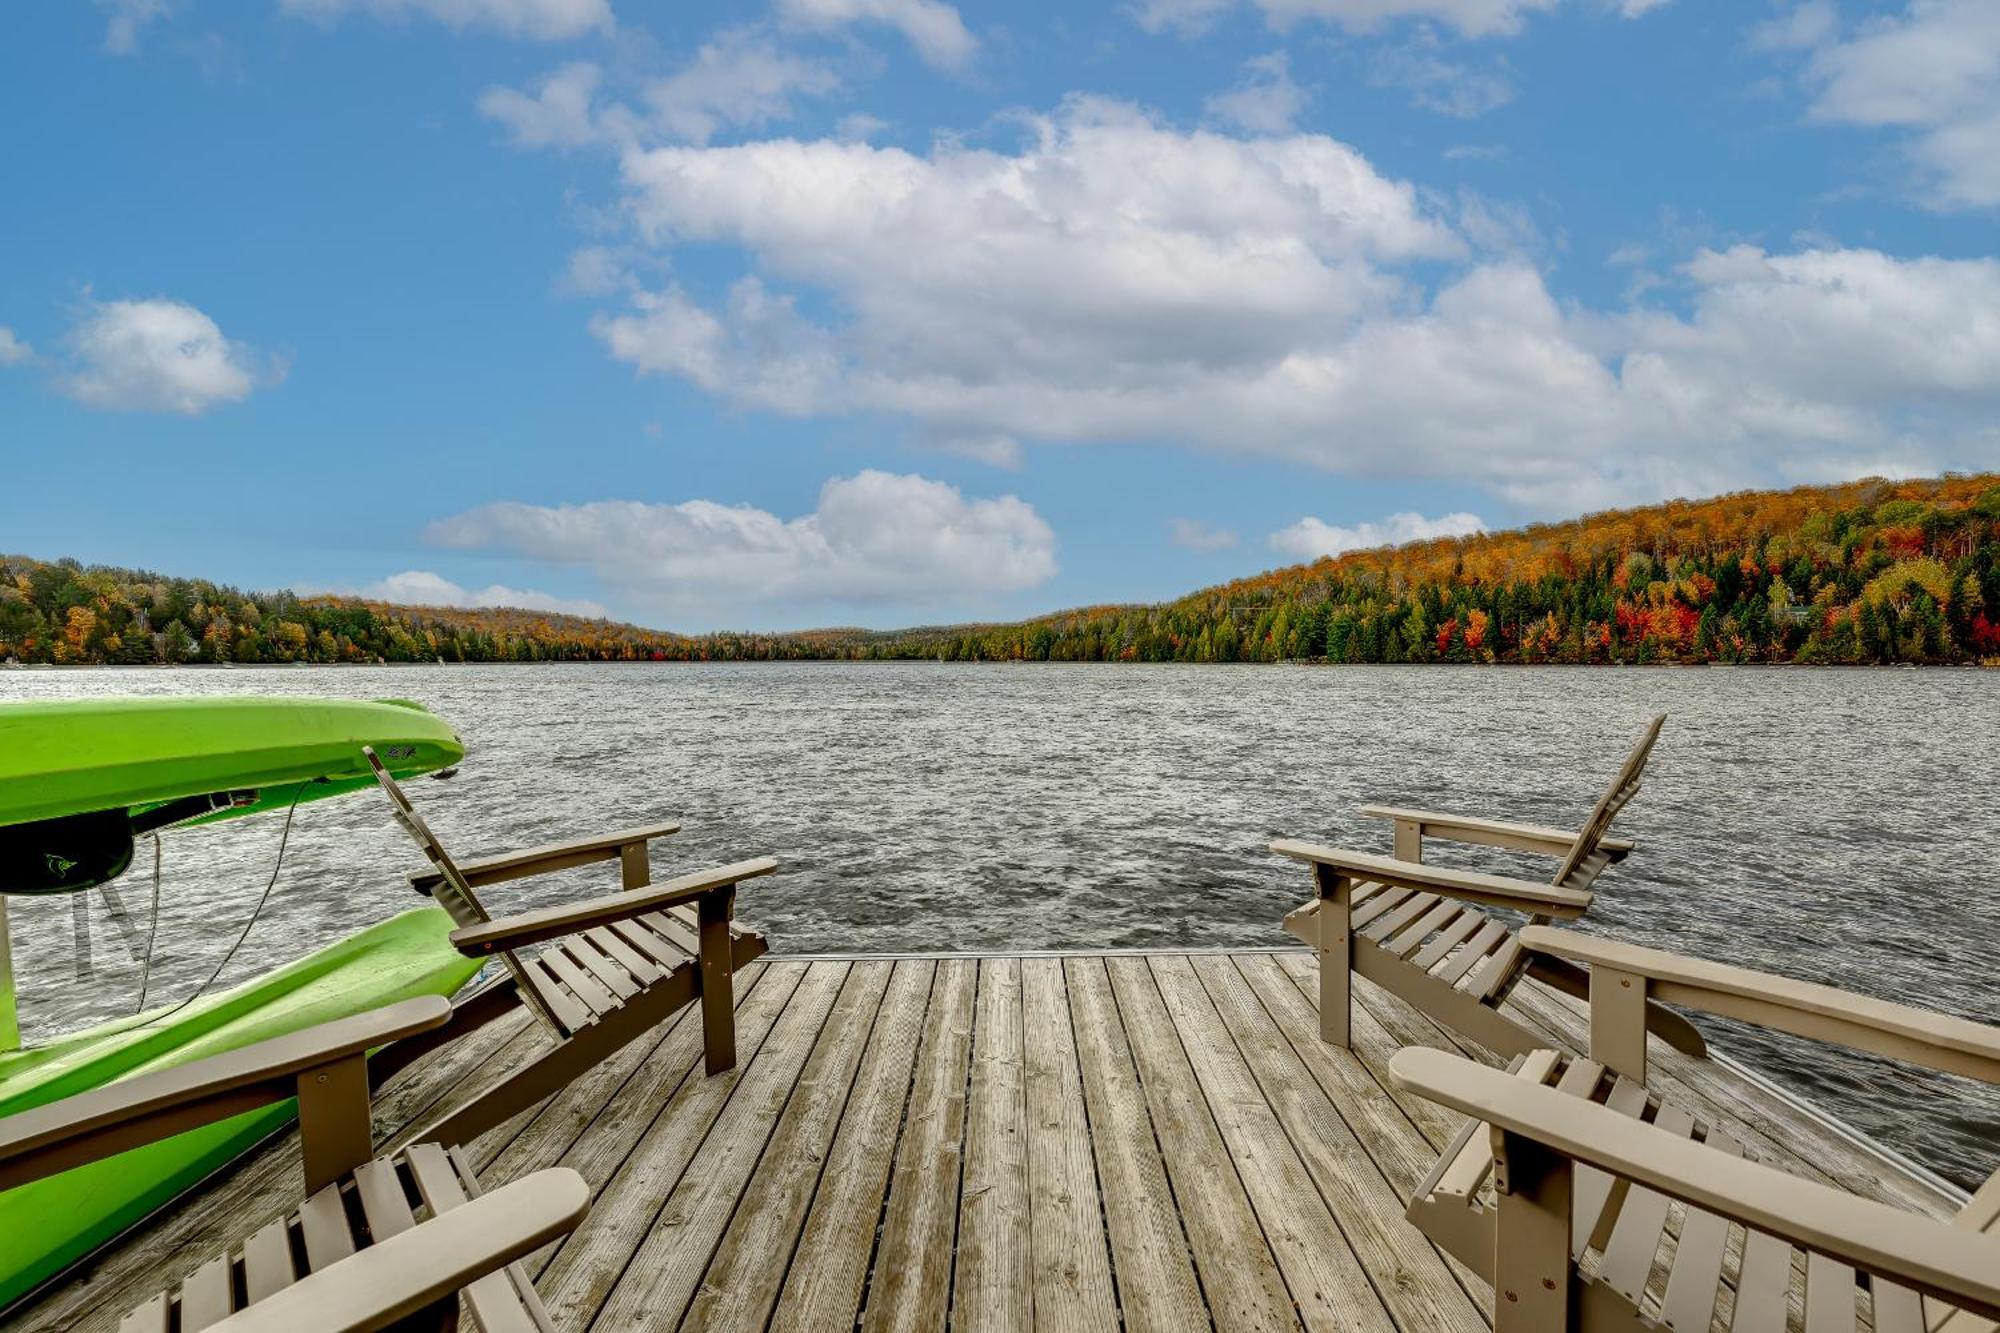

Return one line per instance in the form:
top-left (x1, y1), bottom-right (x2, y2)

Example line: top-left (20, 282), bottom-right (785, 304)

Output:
top-left (10, 951), bottom-right (1956, 1333)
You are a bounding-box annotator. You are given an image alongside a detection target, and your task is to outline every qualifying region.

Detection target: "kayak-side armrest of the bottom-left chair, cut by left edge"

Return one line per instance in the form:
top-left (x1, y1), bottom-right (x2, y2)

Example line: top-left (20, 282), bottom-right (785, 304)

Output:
top-left (0, 995), bottom-right (452, 1189)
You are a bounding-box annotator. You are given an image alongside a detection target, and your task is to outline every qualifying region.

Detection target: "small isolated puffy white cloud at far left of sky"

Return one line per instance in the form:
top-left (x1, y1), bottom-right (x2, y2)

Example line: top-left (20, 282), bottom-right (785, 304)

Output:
top-left (58, 296), bottom-right (282, 416)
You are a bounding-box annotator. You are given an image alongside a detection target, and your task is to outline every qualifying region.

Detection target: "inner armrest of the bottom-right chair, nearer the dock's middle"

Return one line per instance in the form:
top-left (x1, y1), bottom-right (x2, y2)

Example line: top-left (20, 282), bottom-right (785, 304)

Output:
top-left (1388, 1047), bottom-right (2000, 1319)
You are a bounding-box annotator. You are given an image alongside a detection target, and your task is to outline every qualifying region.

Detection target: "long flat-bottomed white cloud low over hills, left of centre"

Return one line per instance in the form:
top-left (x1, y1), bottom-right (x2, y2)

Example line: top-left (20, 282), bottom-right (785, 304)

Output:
top-left (426, 470), bottom-right (1056, 610)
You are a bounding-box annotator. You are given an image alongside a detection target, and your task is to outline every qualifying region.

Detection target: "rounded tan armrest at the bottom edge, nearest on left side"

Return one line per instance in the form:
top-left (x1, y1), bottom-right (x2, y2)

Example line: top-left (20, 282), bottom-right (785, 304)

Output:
top-left (210, 1167), bottom-right (590, 1333)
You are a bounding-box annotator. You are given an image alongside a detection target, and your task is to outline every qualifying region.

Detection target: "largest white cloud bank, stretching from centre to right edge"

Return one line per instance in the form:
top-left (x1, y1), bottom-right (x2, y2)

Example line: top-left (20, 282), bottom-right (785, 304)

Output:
top-left (568, 100), bottom-right (2000, 512)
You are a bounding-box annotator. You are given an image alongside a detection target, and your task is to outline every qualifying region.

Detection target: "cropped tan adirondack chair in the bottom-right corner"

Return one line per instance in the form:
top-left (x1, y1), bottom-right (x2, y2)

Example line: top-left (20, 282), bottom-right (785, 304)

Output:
top-left (1390, 927), bottom-right (2000, 1333)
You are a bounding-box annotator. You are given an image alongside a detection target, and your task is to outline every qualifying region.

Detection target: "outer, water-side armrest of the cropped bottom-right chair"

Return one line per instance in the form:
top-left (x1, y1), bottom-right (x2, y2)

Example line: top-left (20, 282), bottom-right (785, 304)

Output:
top-left (1520, 927), bottom-right (2000, 1083)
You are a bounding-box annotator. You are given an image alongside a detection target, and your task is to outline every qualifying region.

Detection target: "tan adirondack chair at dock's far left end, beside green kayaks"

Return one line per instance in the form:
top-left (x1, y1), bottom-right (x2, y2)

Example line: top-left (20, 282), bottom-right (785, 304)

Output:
top-left (364, 751), bottom-right (778, 1145)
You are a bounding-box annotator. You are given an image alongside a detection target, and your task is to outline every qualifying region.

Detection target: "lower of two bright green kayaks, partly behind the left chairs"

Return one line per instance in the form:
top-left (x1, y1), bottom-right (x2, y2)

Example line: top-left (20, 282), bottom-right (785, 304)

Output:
top-left (0, 907), bottom-right (480, 1309)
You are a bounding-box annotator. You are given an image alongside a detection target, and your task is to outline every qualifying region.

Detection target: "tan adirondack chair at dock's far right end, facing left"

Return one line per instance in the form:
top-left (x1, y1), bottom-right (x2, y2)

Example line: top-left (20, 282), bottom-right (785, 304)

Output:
top-left (1270, 715), bottom-right (1708, 1057)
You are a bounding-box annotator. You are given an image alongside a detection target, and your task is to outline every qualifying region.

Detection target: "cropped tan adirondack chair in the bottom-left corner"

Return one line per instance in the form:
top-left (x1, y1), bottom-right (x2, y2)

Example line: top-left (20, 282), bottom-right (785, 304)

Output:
top-left (0, 995), bottom-right (590, 1333)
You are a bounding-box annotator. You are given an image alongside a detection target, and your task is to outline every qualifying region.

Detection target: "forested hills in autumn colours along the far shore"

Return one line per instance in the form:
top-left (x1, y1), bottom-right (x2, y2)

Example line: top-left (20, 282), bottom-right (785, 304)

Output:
top-left (0, 474), bottom-right (2000, 664)
